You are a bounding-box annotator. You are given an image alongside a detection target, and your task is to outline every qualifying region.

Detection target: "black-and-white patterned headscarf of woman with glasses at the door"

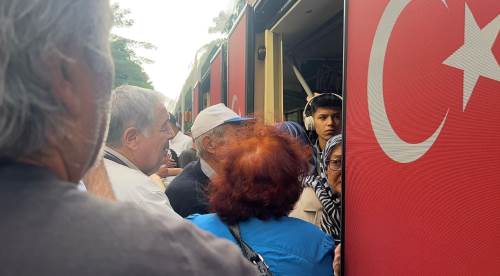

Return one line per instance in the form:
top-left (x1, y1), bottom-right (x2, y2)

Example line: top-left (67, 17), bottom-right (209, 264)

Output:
top-left (303, 134), bottom-right (342, 239)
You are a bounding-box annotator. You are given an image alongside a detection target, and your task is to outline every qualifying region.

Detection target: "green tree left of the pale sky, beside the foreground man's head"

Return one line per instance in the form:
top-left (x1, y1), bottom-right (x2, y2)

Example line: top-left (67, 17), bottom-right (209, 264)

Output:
top-left (111, 3), bottom-right (154, 89)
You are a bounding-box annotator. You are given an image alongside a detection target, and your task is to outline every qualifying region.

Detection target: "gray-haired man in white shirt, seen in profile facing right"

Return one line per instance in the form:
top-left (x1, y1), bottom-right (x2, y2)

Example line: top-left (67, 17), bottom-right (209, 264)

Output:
top-left (104, 85), bottom-right (180, 219)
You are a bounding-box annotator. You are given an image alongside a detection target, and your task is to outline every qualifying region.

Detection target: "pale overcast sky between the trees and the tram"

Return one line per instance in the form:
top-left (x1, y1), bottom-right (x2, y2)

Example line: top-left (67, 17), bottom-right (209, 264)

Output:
top-left (112, 0), bottom-right (233, 100)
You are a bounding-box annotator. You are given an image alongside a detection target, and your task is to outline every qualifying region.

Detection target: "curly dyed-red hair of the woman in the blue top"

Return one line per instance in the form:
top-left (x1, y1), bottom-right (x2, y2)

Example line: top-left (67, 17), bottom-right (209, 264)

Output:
top-left (209, 125), bottom-right (310, 224)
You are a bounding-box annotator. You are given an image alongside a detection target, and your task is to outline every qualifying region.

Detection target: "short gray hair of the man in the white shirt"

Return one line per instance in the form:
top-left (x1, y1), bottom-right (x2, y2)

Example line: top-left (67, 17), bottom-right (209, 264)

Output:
top-left (106, 85), bottom-right (165, 147)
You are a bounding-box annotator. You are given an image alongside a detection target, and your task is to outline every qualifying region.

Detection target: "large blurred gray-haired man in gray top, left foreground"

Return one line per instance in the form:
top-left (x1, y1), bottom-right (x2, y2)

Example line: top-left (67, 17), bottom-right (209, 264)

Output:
top-left (0, 0), bottom-right (255, 276)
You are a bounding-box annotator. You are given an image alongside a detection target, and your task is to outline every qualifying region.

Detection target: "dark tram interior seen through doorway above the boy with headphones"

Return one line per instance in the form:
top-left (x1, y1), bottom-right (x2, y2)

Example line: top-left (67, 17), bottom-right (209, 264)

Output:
top-left (275, 0), bottom-right (343, 122)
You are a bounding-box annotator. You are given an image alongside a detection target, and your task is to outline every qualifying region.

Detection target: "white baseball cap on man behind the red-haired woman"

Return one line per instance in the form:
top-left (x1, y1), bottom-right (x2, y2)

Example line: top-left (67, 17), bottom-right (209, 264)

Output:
top-left (191, 103), bottom-right (253, 139)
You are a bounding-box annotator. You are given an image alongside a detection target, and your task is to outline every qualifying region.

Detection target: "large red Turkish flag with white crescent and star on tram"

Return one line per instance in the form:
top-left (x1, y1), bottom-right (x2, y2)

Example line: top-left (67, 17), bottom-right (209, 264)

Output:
top-left (343, 0), bottom-right (500, 275)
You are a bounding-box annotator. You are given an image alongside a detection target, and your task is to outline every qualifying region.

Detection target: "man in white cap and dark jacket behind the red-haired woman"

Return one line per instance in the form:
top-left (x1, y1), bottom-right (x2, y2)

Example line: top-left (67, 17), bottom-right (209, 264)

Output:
top-left (165, 103), bottom-right (250, 217)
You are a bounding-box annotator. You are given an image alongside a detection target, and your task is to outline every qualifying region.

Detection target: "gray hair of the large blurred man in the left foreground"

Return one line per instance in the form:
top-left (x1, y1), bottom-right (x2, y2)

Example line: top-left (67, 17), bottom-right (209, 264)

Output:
top-left (0, 0), bottom-right (113, 159)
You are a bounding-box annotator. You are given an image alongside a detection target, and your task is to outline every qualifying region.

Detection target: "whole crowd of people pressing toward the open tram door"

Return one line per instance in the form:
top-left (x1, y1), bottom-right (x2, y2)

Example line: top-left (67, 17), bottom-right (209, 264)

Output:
top-left (0, 0), bottom-right (342, 275)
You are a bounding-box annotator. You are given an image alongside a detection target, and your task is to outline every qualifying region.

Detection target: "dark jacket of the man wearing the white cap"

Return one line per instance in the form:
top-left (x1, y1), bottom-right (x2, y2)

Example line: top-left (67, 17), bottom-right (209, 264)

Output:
top-left (165, 160), bottom-right (210, 217)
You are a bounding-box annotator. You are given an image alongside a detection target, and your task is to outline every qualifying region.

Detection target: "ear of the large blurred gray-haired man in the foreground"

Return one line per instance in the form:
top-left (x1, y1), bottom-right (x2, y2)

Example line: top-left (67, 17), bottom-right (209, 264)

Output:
top-left (50, 58), bottom-right (81, 117)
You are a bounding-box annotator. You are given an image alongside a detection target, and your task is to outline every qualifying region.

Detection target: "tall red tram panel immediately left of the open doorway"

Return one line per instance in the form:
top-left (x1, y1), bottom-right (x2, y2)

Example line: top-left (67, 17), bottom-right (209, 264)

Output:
top-left (227, 11), bottom-right (247, 115)
